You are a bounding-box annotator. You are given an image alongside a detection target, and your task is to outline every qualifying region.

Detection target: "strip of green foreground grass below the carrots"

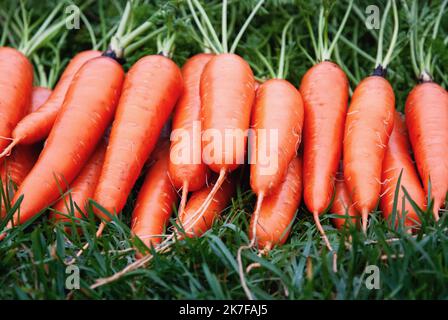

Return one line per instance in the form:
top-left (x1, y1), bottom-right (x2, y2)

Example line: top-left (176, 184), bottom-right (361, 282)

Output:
top-left (0, 188), bottom-right (448, 299)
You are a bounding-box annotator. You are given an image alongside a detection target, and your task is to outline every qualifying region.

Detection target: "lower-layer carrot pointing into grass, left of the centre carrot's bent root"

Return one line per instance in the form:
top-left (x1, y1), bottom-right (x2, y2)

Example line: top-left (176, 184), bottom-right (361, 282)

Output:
top-left (131, 144), bottom-right (177, 256)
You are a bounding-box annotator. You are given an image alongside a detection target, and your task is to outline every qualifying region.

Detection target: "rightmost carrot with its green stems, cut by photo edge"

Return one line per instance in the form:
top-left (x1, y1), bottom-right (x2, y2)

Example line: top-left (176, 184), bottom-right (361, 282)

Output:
top-left (405, 1), bottom-right (448, 221)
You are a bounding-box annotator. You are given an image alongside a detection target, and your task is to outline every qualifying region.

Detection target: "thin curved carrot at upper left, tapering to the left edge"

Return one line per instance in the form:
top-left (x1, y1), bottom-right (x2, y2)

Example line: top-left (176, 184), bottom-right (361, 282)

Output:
top-left (0, 50), bottom-right (101, 157)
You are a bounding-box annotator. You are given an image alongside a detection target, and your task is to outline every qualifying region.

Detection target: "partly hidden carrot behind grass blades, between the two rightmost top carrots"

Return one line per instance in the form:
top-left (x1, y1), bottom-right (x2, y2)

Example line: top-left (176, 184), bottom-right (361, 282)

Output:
top-left (380, 111), bottom-right (425, 227)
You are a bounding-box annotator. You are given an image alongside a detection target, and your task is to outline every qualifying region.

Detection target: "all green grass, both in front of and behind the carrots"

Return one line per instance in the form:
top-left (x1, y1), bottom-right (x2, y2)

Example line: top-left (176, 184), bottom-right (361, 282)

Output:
top-left (0, 0), bottom-right (448, 299)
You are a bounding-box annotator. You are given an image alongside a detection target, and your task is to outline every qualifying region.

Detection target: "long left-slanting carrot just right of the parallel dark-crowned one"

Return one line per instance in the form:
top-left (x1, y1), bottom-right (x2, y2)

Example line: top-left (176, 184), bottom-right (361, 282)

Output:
top-left (94, 55), bottom-right (182, 221)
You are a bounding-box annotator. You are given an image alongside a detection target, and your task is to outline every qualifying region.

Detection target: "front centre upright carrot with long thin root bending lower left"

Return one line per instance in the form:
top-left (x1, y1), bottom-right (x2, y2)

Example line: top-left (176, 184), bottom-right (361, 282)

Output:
top-left (187, 53), bottom-right (255, 228)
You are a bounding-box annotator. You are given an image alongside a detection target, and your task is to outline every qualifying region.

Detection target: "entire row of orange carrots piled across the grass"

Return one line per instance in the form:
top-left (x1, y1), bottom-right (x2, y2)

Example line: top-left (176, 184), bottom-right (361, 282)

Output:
top-left (0, 1), bottom-right (448, 266)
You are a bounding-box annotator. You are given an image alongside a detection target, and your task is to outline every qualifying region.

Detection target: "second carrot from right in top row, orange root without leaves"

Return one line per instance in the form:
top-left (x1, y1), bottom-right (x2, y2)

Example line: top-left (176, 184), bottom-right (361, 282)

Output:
top-left (344, 75), bottom-right (395, 231)
